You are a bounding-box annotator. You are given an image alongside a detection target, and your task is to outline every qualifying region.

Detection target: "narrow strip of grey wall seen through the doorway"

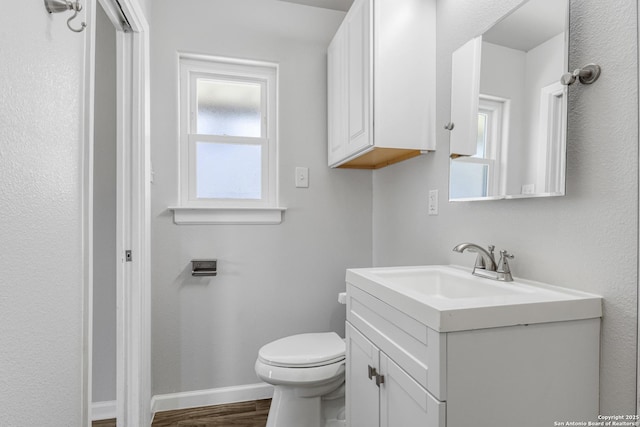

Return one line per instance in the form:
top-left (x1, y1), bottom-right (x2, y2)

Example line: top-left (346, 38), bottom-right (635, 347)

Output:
top-left (92, 2), bottom-right (116, 402)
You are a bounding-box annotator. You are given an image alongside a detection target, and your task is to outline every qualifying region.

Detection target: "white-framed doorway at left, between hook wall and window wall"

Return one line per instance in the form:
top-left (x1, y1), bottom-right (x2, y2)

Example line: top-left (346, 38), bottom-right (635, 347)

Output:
top-left (84, 0), bottom-right (151, 427)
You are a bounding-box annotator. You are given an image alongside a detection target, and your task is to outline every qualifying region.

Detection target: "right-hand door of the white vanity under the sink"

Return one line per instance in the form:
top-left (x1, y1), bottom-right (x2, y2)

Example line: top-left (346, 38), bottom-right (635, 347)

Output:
top-left (379, 353), bottom-right (446, 427)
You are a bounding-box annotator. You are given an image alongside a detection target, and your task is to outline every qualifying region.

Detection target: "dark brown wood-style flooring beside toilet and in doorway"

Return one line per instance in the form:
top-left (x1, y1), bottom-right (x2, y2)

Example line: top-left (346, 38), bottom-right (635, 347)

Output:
top-left (92, 399), bottom-right (271, 427)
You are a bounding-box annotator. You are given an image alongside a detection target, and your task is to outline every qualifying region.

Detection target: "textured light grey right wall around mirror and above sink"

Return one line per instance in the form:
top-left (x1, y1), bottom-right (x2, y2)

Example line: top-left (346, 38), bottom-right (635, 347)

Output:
top-left (373, 0), bottom-right (638, 414)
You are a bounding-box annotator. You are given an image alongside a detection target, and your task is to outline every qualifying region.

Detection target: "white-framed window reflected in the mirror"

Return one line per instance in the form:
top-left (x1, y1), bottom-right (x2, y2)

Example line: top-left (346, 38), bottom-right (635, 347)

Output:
top-left (450, 95), bottom-right (509, 199)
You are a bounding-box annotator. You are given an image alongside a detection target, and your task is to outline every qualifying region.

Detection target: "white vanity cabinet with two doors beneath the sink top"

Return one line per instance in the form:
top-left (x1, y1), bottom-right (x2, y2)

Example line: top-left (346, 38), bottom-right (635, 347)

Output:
top-left (346, 283), bottom-right (600, 427)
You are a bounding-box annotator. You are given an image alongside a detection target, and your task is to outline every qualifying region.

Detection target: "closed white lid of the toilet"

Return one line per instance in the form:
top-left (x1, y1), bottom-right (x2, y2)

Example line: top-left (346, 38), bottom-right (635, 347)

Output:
top-left (258, 332), bottom-right (346, 368)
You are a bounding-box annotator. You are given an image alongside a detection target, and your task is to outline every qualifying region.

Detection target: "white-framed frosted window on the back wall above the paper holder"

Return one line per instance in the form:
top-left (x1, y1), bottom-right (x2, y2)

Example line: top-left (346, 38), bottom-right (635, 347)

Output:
top-left (173, 55), bottom-right (283, 223)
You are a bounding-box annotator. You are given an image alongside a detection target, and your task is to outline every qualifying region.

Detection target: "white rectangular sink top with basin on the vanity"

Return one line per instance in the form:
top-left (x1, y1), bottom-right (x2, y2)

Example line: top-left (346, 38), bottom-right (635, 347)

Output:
top-left (346, 265), bottom-right (602, 332)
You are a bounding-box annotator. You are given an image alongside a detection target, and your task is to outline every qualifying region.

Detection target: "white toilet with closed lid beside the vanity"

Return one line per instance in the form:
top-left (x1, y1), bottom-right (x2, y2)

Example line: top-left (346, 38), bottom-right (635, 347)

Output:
top-left (255, 332), bottom-right (346, 427)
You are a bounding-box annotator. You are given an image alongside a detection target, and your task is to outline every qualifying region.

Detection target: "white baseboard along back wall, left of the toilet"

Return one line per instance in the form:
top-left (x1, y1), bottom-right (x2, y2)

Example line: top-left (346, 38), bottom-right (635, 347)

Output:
top-left (151, 383), bottom-right (273, 414)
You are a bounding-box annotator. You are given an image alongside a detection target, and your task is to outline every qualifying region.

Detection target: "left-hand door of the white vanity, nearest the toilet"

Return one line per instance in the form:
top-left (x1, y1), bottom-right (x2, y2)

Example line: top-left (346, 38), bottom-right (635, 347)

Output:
top-left (346, 322), bottom-right (378, 427)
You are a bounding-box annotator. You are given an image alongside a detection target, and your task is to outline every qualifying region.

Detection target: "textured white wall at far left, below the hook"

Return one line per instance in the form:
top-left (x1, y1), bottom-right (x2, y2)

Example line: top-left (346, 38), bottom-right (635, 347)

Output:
top-left (0, 1), bottom-right (92, 426)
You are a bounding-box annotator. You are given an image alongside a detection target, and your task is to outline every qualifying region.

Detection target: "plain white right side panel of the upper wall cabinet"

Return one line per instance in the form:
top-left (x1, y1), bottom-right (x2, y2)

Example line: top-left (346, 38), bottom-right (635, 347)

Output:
top-left (373, 0), bottom-right (436, 150)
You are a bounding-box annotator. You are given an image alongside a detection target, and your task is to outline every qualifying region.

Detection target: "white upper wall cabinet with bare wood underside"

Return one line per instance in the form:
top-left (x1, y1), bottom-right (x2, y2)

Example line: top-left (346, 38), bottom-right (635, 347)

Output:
top-left (328, 0), bottom-right (436, 169)
